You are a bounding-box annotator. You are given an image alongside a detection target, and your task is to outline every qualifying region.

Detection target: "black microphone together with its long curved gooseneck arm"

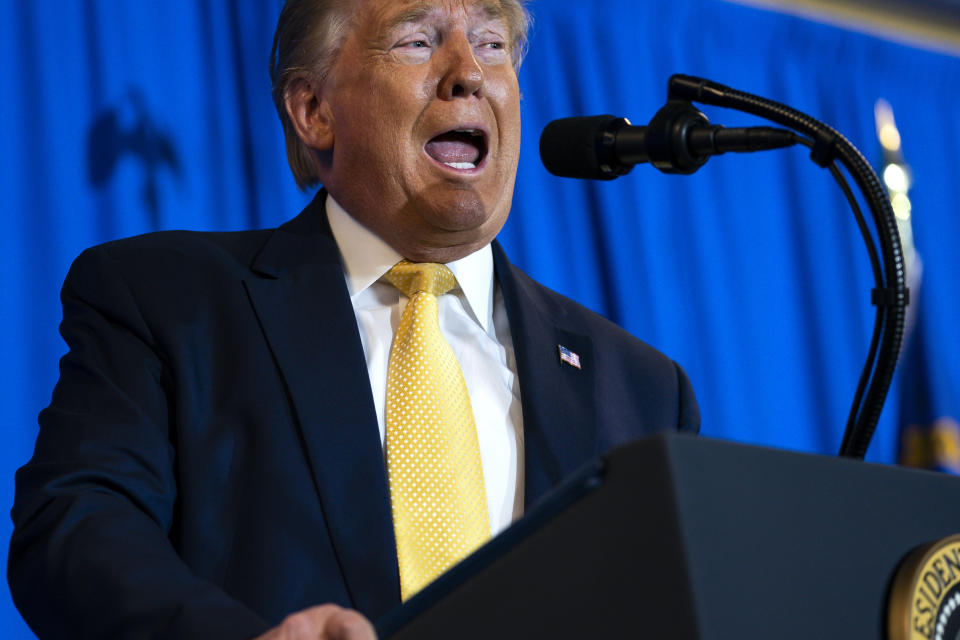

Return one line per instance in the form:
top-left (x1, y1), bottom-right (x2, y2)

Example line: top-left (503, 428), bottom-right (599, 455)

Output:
top-left (540, 75), bottom-right (910, 458)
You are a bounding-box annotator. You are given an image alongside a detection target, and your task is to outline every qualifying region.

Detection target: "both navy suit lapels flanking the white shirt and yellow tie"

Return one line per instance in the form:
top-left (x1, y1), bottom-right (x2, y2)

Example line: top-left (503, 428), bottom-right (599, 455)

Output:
top-left (244, 214), bottom-right (596, 617)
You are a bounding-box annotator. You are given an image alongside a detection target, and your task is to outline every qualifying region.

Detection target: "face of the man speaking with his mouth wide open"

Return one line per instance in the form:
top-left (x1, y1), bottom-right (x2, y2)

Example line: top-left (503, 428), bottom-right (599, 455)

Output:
top-left (320, 0), bottom-right (520, 262)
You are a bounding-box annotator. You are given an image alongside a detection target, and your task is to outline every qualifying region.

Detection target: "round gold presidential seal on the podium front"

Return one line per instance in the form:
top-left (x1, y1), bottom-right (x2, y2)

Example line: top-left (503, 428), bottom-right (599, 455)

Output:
top-left (887, 535), bottom-right (960, 640)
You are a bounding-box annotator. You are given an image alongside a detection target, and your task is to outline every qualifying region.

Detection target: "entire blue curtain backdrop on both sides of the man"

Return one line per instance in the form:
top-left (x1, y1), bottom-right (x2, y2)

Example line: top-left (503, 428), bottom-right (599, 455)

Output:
top-left (0, 0), bottom-right (960, 638)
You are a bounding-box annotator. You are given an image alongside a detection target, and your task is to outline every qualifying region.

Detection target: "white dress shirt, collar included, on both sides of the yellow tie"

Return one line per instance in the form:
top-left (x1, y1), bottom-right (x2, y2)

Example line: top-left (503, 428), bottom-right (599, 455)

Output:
top-left (326, 195), bottom-right (523, 535)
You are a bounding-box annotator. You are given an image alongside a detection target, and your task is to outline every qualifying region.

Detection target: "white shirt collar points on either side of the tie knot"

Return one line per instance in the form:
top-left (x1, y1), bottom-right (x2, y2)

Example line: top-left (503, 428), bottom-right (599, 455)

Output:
top-left (326, 194), bottom-right (493, 332)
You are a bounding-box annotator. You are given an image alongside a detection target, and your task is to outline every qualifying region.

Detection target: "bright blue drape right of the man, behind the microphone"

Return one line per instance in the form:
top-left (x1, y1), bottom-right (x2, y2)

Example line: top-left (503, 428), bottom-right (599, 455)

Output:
top-left (507, 0), bottom-right (960, 460)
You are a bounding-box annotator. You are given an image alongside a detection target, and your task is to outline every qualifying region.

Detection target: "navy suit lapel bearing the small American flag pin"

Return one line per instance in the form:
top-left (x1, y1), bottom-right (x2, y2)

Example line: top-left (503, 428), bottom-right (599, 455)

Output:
top-left (493, 242), bottom-right (596, 509)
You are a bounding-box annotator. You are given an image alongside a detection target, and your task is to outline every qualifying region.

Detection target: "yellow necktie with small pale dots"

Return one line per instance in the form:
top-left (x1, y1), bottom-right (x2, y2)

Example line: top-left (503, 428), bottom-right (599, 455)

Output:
top-left (384, 261), bottom-right (490, 600)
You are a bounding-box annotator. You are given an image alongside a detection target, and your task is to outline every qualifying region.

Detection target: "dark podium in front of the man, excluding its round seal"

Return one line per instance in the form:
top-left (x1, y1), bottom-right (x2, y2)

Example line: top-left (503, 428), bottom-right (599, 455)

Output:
top-left (377, 433), bottom-right (960, 640)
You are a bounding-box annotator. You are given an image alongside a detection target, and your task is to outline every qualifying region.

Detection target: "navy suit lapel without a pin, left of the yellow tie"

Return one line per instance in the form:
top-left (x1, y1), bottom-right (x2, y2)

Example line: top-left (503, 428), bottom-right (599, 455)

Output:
top-left (245, 192), bottom-right (399, 616)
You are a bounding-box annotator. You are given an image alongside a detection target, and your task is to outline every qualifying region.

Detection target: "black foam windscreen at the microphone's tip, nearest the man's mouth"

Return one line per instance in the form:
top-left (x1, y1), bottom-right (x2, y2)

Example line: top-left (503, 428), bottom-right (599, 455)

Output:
top-left (540, 115), bottom-right (623, 180)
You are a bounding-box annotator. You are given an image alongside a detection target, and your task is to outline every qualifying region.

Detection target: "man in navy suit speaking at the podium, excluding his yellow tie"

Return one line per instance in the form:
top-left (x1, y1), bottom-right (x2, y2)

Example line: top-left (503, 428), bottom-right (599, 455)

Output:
top-left (9, 0), bottom-right (699, 638)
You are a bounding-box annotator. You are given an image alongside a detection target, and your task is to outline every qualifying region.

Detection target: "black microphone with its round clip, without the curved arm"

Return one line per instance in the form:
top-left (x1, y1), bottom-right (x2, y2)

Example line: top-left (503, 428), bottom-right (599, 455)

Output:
top-left (540, 100), bottom-right (799, 180)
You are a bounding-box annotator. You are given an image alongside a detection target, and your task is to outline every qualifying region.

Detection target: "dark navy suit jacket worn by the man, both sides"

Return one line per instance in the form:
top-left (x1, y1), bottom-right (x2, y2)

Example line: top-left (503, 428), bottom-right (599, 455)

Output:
top-left (8, 193), bottom-right (699, 638)
